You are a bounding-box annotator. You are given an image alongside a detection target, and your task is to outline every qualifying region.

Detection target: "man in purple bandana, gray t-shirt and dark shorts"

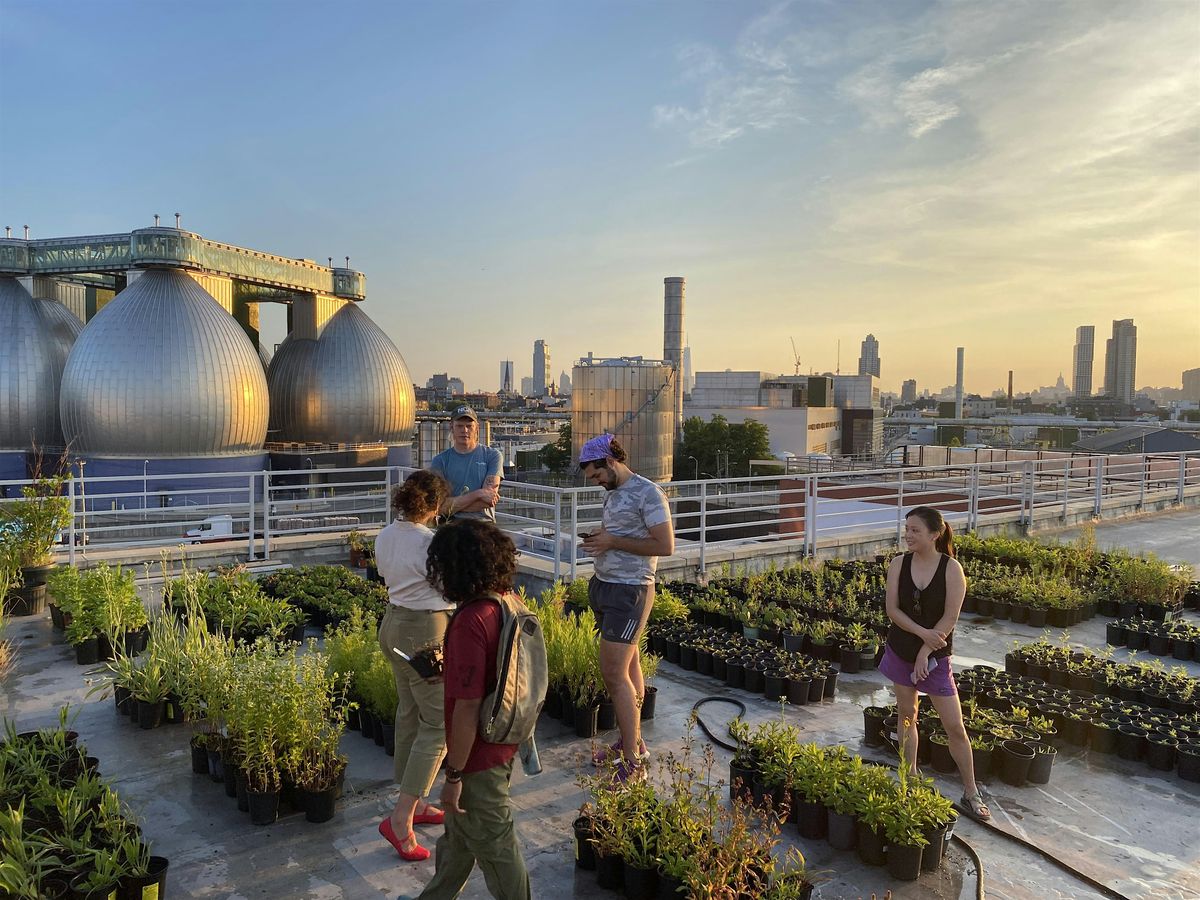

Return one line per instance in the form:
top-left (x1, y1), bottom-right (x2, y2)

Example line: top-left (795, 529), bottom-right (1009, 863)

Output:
top-left (580, 434), bottom-right (674, 781)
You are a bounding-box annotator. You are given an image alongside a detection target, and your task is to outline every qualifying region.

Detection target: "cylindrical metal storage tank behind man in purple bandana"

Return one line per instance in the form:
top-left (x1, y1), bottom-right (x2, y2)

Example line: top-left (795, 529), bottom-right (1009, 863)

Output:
top-left (571, 358), bottom-right (674, 482)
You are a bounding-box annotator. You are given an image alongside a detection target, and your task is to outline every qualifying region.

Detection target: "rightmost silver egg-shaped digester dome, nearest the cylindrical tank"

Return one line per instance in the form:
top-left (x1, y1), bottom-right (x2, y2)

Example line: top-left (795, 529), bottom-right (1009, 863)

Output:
top-left (268, 304), bottom-right (416, 444)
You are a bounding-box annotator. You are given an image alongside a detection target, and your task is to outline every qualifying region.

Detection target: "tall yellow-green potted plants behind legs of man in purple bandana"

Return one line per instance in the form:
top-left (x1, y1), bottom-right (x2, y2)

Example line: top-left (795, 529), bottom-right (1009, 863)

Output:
top-left (537, 580), bottom-right (662, 738)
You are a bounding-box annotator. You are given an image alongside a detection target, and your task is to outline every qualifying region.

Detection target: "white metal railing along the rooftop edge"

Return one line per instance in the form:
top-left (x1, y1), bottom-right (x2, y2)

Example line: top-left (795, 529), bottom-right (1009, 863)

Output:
top-left (0, 452), bottom-right (1200, 577)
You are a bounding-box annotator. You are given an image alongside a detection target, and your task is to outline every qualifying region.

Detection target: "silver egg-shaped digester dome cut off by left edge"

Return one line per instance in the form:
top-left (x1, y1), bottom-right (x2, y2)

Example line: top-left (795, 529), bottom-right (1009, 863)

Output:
top-left (0, 278), bottom-right (83, 450)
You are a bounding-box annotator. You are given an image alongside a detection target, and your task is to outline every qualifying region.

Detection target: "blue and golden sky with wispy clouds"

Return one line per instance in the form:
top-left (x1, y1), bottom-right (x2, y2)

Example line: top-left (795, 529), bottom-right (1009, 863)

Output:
top-left (0, 0), bottom-right (1200, 394)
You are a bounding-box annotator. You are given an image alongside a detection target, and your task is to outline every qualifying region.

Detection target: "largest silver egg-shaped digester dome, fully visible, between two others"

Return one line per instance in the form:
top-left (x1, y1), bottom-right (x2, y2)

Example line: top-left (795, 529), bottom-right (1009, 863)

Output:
top-left (60, 269), bottom-right (269, 457)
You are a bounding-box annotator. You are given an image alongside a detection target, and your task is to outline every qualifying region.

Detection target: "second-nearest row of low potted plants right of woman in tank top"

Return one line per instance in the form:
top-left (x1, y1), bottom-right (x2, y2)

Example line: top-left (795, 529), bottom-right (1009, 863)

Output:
top-left (1004, 632), bottom-right (1200, 714)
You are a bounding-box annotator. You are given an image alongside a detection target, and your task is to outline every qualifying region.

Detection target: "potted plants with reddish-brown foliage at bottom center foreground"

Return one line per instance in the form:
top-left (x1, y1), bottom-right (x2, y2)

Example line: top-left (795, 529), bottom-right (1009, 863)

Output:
top-left (575, 724), bottom-right (814, 900)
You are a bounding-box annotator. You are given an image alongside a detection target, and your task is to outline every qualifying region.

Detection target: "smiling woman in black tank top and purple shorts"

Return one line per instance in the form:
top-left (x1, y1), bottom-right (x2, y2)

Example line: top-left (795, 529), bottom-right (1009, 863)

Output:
top-left (880, 506), bottom-right (991, 820)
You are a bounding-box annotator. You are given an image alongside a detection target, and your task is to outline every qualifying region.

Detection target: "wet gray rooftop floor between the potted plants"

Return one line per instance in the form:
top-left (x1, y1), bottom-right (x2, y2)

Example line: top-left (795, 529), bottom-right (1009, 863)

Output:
top-left (0, 511), bottom-right (1200, 900)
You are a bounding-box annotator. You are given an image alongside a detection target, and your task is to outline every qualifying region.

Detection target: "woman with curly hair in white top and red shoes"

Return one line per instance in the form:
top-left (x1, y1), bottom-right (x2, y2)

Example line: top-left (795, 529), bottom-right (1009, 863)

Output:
top-left (376, 470), bottom-right (454, 863)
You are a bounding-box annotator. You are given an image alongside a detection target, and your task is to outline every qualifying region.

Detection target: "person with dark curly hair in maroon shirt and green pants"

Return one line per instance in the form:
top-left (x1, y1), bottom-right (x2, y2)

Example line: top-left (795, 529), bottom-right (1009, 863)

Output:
top-left (405, 518), bottom-right (532, 900)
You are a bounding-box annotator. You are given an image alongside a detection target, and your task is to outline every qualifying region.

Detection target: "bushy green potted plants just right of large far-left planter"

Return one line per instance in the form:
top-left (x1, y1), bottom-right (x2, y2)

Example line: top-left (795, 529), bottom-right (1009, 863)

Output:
top-left (48, 563), bottom-right (148, 665)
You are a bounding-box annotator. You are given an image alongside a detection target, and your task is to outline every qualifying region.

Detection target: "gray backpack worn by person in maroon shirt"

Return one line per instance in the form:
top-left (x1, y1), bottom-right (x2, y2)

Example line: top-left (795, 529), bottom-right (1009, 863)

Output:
top-left (479, 594), bottom-right (550, 744)
